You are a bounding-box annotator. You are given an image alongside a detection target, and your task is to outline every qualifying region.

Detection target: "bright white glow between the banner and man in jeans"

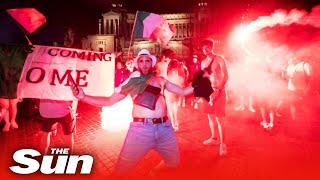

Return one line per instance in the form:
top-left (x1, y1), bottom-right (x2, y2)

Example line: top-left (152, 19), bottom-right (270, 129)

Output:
top-left (100, 96), bottom-right (132, 132)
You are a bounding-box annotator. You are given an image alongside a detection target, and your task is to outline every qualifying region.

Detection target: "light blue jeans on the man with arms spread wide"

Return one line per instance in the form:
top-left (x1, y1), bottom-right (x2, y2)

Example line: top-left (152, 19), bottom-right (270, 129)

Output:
top-left (115, 121), bottom-right (180, 175)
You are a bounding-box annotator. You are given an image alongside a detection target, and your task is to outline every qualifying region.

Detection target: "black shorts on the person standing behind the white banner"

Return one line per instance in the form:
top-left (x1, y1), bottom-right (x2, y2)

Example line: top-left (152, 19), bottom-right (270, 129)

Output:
top-left (41, 113), bottom-right (76, 135)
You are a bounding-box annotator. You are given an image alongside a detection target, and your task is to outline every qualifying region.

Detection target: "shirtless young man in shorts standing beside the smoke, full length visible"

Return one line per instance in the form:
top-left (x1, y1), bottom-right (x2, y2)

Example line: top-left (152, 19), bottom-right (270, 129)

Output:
top-left (201, 39), bottom-right (229, 156)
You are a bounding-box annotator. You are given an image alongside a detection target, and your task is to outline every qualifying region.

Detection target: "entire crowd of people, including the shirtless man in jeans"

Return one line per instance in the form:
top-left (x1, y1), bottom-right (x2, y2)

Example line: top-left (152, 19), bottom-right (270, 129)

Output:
top-left (0, 36), bottom-right (319, 175)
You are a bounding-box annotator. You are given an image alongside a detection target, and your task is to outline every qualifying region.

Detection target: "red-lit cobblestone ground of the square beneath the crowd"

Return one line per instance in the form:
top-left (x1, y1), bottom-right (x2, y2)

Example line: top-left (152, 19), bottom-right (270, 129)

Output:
top-left (0, 98), bottom-right (320, 179)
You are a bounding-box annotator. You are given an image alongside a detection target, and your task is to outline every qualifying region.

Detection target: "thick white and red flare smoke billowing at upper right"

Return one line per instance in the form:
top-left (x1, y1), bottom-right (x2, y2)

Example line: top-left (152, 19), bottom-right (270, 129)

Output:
top-left (228, 5), bottom-right (320, 107)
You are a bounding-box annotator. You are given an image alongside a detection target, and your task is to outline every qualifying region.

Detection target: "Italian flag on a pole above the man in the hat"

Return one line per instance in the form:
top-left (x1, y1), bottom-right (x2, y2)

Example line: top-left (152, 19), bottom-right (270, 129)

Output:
top-left (133, 11), bottom-right (176, 45)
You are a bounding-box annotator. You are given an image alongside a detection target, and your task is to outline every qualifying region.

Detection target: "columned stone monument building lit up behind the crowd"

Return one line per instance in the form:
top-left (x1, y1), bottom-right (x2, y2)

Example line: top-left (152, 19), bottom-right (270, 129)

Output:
top-left (82, 0), bottom-right (220, 59)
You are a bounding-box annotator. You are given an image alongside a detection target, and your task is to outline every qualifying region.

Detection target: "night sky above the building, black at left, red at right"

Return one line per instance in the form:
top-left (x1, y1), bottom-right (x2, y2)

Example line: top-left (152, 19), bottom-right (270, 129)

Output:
top-left (0, 0), bottom-right (320, 42)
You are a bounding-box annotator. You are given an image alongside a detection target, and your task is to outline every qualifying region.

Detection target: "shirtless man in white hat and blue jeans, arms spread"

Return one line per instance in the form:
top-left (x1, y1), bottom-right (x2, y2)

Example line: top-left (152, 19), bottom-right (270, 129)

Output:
top-left (71, 49), bottom-right (193, 175)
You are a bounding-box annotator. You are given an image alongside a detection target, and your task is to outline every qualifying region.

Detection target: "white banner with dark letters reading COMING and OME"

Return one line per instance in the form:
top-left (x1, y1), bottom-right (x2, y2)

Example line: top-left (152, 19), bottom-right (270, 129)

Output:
top-left (18, 45), bottom-right (116, 100)
